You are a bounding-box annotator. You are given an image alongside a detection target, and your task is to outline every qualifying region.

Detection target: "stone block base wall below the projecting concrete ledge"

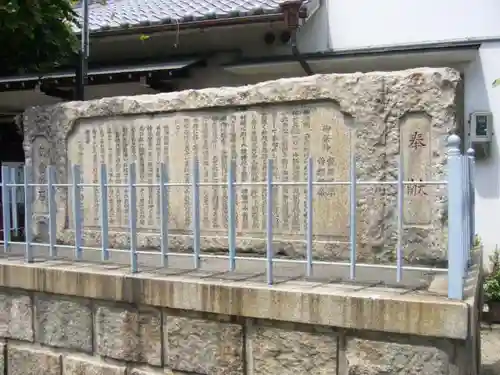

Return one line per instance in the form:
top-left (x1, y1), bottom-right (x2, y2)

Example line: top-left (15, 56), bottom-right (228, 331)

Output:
top-left (0, 289), bottom-right (465, 375)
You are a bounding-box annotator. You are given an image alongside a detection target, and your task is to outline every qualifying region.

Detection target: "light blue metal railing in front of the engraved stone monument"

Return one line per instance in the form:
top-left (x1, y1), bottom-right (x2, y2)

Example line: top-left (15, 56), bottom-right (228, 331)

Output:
top-left (1, 135), bottom-right (474, 299)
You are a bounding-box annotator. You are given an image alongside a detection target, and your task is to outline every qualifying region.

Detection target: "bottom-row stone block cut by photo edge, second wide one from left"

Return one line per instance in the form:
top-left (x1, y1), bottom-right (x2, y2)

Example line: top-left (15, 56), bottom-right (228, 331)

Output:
top-left (63, 355), bottom-right (127, 375)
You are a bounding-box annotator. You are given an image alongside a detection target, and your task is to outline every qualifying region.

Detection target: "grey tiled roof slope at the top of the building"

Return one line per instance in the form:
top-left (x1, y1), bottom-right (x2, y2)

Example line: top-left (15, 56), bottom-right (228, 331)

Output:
top-left (75, 0), bottom-right (283, 32)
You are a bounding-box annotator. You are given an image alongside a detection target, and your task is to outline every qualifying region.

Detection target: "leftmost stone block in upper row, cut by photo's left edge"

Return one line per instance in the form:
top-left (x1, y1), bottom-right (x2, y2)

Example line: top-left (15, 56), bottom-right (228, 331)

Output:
top-left (0, 293), bottom-right (33, 341)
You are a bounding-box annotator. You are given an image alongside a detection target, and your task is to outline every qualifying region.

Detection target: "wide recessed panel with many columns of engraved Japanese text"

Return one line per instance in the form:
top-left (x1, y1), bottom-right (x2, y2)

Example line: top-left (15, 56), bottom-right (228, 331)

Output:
top-left (68, 102), bottom-right (351, 239)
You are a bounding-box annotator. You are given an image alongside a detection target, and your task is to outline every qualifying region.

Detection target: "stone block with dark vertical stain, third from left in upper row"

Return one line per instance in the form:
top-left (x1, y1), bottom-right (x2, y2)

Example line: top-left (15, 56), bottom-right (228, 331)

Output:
top-left (95, 305), bottom-right (162, 366)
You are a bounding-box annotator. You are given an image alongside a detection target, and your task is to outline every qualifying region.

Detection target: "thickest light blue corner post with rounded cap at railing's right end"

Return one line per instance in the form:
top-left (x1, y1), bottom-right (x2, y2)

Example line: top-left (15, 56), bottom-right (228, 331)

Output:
top-left (448, 134), bottom-right (465, 300)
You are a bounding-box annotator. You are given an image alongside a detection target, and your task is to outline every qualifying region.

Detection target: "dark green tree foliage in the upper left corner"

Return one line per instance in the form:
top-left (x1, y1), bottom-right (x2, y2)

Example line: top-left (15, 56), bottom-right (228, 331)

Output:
top-left (0, 0), bottom-right (78, 74)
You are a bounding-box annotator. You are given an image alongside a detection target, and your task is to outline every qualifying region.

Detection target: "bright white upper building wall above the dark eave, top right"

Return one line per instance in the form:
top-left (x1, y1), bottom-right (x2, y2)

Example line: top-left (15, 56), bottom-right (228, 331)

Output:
top-left (326, 0), bottom-right (500, 50)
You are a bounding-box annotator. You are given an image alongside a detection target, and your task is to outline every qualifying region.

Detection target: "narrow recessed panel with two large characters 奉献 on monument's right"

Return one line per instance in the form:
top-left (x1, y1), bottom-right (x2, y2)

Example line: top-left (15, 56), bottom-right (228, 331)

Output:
top-left (400, 113), bottom-right (432, 225)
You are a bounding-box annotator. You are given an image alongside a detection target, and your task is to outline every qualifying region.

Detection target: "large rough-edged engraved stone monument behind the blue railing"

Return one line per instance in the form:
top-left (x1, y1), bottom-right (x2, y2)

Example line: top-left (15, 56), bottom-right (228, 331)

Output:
top-left (24, 68), bottom-right (460, 263)
